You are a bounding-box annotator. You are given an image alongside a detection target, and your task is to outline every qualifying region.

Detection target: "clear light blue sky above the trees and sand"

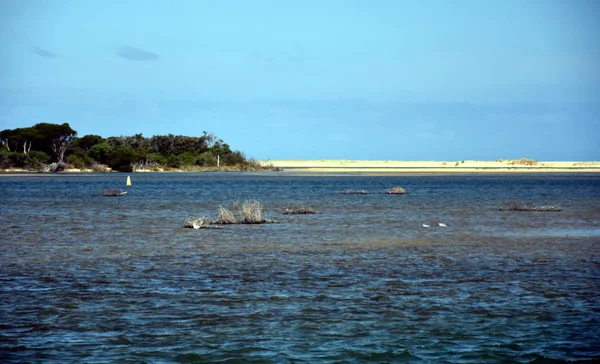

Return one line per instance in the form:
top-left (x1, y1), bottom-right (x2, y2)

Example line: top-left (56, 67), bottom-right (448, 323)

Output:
top-left (0, 0), bottom-right (600, 161)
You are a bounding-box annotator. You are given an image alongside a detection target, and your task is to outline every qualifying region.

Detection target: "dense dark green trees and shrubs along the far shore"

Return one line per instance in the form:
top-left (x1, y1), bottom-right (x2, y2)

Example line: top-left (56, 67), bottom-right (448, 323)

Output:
top-left (0, 123), bottom-right (268, 172)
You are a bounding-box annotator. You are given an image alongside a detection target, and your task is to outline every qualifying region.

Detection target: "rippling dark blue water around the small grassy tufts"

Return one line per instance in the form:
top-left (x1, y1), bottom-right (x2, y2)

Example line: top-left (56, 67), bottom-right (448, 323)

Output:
top-left (0, 173), bottom-right (600, 363)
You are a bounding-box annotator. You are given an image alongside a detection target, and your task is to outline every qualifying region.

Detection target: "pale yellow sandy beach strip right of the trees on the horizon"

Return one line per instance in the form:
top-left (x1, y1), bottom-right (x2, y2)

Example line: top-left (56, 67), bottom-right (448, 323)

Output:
top-left (261, 159), bottom-right (600, 173)
